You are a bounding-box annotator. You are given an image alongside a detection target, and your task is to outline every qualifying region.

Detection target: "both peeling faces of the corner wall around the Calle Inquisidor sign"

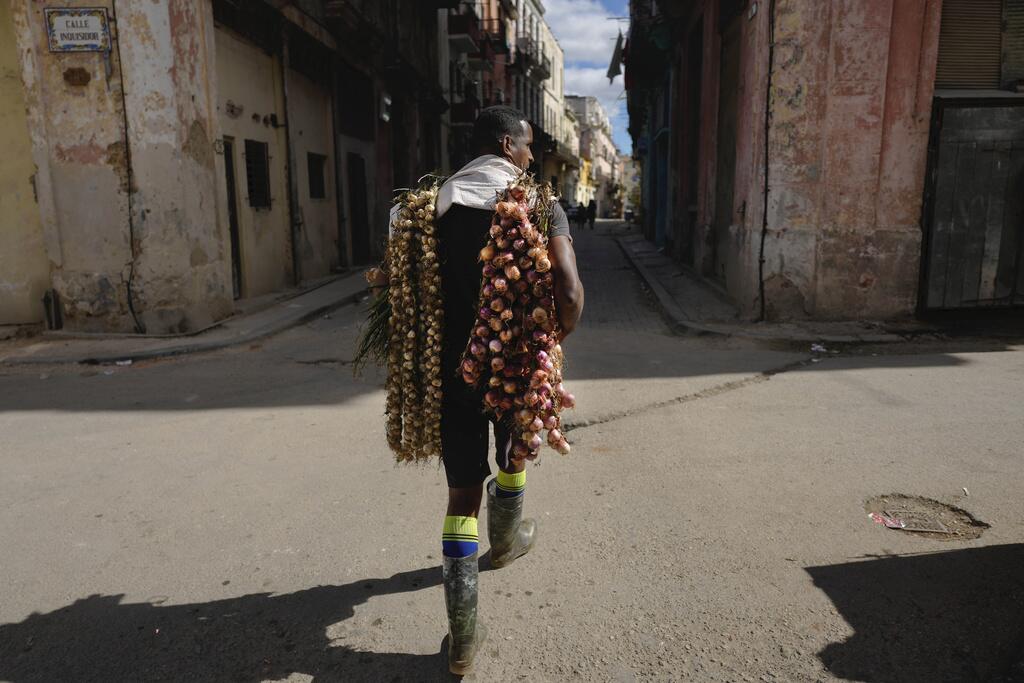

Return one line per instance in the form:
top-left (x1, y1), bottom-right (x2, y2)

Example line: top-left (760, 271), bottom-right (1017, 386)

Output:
top-left (12, 0), bottom-right (231, 334)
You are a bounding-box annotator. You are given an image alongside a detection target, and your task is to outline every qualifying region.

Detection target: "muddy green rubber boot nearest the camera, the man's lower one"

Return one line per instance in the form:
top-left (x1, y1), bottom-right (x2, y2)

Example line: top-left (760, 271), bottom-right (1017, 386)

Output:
top-left (442, 553), bottom-right (487, 676)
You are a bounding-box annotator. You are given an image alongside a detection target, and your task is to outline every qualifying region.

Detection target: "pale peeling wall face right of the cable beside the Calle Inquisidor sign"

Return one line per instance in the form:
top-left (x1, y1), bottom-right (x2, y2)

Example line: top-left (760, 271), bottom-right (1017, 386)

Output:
top-left (117, 0), bottom-right (232, 332)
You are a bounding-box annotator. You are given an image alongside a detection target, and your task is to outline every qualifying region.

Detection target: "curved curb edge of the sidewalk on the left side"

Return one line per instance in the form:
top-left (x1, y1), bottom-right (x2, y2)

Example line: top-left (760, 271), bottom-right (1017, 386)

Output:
top-left (0, 288), bottom-right (370, 367)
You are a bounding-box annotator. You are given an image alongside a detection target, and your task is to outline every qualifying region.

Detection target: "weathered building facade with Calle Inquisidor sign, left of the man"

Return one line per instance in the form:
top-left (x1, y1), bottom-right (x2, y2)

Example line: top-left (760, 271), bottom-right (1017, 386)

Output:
top-left (0, 0), bottom-right (446, 334)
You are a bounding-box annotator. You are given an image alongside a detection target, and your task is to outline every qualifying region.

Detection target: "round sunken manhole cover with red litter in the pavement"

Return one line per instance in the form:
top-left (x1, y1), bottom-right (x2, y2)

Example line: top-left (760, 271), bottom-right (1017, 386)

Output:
top-left (864, 494), bottom-right (988, 541)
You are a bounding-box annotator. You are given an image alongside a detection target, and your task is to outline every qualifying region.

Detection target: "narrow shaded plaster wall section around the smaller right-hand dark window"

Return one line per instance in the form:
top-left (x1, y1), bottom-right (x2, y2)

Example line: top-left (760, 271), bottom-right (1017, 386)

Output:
top-left (288, 71), bottom-right (340, 280)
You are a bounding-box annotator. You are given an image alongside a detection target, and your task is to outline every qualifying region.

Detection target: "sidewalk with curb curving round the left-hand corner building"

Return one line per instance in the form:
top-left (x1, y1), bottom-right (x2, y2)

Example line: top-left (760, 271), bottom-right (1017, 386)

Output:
top-left (0, 271), bottom-right (367, 366)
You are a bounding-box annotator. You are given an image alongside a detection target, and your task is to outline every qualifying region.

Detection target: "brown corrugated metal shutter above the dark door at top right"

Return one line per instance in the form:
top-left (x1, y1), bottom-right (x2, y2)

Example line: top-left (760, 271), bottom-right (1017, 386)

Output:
top-left (935, 0), bottom-right (1002, 88)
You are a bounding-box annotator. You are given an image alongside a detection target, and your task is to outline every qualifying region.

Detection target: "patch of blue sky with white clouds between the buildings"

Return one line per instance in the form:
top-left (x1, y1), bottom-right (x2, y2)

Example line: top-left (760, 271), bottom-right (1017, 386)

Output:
top-left (543, 0), bottom-right (633, 153)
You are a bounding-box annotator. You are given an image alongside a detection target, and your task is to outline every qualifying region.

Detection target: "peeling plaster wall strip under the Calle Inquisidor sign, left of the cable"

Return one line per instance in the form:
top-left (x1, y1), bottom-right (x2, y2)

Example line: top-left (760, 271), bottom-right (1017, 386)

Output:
top-left (11, 0), bottom-right (133, 332)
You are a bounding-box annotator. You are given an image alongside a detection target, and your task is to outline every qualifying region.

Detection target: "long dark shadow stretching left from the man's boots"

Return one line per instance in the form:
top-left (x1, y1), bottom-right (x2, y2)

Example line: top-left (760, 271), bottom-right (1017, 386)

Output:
top-left (0, 555), bottom-right (489, 683)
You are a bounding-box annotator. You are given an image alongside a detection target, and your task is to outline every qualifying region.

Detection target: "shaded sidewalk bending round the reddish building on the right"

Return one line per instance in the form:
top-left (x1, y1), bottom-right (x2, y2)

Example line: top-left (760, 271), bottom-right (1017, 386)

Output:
top-left (615, 225), bottom-right (938, 343)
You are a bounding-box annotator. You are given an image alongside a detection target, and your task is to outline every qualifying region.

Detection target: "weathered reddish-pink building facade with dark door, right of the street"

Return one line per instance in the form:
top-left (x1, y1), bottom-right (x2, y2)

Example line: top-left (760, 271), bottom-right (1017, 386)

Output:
top-left (626, 0), bottom-right (1024, 319)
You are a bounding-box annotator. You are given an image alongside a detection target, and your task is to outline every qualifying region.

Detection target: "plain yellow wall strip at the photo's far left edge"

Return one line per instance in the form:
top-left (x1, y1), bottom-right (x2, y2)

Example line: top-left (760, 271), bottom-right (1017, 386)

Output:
top-left (0, 2), bottom-right (50, 325)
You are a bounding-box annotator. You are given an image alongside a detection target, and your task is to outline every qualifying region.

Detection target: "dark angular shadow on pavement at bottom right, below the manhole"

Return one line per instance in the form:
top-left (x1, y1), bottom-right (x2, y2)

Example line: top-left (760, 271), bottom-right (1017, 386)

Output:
top-left (807, 544), bottom-right (1024, 683)
